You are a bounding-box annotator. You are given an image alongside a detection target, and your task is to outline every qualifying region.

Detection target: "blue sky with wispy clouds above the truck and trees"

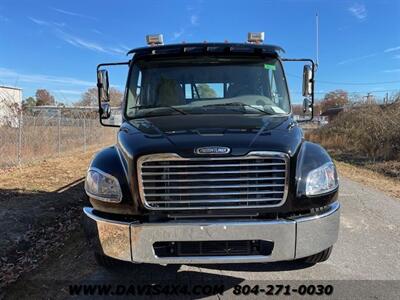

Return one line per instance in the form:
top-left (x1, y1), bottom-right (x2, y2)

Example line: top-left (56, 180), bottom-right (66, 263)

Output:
top-left (0, 0), bottom-right (400, 104)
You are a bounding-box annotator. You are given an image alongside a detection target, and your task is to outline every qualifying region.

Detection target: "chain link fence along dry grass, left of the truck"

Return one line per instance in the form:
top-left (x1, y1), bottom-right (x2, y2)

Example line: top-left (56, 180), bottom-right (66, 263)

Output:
top-left (0, 107), bottom-right (118, 168)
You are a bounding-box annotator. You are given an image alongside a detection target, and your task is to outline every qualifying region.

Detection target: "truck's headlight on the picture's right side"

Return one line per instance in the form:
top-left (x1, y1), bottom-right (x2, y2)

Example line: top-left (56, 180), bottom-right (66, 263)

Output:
top-left (306, 162), bottom-right (339, 196)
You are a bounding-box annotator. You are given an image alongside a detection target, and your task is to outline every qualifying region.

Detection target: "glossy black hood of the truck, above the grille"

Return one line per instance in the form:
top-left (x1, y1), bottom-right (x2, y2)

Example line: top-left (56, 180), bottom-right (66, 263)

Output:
top-left (118, 115), bottom-right (303, 158)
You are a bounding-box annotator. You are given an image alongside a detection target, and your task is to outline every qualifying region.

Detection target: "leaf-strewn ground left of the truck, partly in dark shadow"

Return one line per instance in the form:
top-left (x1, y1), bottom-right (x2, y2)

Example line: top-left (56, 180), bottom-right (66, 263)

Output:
top-left (0, 149), bottom-right (97, 287)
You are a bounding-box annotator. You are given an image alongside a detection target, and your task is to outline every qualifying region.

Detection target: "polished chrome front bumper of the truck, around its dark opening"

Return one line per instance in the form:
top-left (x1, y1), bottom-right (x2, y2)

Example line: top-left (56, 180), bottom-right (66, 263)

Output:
top-left (83, 202), bottom-right (340, 264)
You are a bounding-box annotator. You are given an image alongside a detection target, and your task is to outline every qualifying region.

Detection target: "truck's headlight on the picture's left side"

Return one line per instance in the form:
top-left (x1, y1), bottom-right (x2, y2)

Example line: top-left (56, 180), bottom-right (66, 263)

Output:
top-left (85, 168), bottom-right (122, 202)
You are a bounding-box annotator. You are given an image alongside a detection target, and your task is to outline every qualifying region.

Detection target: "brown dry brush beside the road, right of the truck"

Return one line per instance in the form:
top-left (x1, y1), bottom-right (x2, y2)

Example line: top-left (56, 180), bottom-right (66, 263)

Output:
top-left (306, 102), bottom-right (400, 160)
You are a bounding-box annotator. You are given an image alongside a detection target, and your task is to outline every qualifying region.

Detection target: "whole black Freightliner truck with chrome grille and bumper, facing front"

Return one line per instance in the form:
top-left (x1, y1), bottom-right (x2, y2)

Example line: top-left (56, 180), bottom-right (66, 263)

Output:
top-left (83, 33), bottom-right (340, 266)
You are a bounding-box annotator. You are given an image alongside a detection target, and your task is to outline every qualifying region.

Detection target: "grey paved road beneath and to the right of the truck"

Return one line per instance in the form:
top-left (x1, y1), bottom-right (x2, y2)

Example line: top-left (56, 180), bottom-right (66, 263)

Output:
top-left (3, 178), bottom-right (400, 298)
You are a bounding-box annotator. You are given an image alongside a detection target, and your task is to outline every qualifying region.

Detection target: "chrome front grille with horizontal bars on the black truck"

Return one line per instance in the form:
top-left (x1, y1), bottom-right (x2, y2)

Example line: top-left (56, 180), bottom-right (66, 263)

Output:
top-left (137, 152), bottom-right (289, 210)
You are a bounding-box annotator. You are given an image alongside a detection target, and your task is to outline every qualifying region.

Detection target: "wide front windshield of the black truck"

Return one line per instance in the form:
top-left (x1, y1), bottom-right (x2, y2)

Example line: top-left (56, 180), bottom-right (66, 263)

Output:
top-left (126, 57), bottom-right (290, 118)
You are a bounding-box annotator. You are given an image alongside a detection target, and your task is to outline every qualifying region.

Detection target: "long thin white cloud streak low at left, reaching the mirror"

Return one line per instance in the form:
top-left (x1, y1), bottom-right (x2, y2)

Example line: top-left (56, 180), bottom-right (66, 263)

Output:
top-left (0, 68), bottom-right (96, 86)
